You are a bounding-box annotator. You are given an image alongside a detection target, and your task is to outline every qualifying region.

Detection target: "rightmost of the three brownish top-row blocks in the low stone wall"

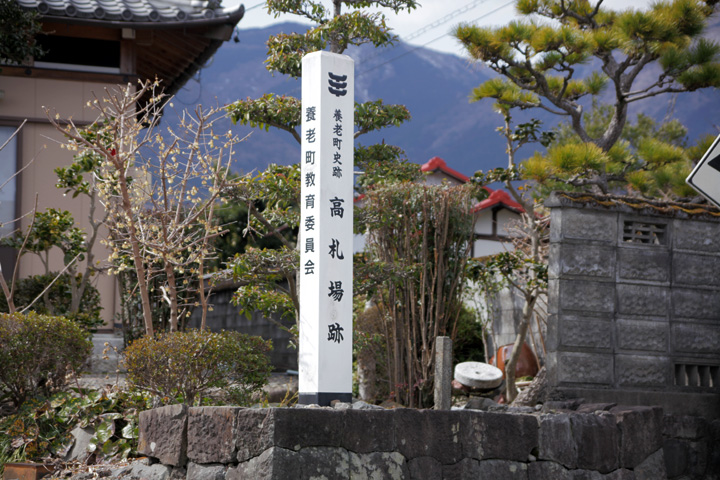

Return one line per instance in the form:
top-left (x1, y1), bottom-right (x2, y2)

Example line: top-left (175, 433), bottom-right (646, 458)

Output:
top-left (235, 408), bottom-right (278, 462)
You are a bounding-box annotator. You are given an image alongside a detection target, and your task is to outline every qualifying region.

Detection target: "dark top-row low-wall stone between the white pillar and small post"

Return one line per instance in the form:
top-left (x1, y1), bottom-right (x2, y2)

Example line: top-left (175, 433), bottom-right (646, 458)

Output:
top-left (340, 409), bottom-right (395, 453)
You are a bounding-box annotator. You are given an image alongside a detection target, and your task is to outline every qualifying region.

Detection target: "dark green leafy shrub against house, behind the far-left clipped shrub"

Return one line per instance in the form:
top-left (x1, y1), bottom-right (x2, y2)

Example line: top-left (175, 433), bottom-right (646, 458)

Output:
top-left (0, 273), bottom-right (103, 331)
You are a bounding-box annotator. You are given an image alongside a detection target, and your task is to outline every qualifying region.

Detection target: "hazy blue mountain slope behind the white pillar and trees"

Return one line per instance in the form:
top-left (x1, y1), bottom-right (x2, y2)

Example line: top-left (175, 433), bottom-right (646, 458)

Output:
top-left (166, 22), bottom-right (720, 175)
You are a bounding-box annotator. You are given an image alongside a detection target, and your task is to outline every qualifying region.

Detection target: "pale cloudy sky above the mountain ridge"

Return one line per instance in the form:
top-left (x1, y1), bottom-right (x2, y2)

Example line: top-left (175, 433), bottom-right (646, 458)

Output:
top-left (223, 0), bottom-right (650, 56)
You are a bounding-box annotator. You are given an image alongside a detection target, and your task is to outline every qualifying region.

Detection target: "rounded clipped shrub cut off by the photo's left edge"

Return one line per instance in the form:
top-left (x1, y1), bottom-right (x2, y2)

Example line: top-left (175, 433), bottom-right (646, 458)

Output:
top-left (0, 312), bottom-right (92, 406)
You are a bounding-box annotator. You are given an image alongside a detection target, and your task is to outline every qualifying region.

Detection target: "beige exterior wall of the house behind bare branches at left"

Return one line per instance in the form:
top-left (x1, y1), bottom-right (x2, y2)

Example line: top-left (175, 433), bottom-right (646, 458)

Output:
top-left (0, 76), bottom-right (117, 326)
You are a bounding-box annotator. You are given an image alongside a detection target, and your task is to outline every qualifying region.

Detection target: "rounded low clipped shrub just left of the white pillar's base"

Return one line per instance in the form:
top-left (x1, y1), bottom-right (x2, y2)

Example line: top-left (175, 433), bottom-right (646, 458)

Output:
top-left (125, 330), bottom-right (272, 405)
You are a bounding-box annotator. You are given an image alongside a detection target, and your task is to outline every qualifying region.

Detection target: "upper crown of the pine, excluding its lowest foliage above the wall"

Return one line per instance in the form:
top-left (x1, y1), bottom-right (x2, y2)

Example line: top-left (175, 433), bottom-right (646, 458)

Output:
top-left (455, 0), bottom-right (720, 158)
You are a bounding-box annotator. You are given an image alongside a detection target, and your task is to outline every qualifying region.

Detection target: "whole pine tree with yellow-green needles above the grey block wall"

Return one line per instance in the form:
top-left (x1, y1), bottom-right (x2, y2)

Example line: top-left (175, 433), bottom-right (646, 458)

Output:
top-left (455, 0), bottom-right (720, 197)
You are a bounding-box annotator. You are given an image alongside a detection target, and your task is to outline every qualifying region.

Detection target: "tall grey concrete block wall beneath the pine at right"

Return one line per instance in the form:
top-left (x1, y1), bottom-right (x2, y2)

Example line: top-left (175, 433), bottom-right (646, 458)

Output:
top-left (546, 194), bottom-right (720, 417)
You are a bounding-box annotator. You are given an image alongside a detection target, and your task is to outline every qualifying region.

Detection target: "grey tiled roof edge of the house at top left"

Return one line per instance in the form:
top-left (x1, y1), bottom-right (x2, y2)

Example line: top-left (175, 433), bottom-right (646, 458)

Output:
top-left (16, 0), bottom-right (244, 24)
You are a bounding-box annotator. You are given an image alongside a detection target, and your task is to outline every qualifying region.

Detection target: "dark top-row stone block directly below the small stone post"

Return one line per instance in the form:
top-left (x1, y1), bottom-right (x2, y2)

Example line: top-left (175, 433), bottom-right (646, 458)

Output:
top-left (394, 408), bottom-right (462, 465)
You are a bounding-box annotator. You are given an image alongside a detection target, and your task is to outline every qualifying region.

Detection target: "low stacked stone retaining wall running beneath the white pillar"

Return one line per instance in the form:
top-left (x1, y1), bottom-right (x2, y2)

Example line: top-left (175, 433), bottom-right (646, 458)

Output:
top-left (139, 404), bottom-right (720, 480)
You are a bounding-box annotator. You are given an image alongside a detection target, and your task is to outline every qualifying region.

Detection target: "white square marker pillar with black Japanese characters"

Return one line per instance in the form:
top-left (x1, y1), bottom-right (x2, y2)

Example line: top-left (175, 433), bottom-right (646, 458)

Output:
top-left (298, 52), bottom-right (355, 405)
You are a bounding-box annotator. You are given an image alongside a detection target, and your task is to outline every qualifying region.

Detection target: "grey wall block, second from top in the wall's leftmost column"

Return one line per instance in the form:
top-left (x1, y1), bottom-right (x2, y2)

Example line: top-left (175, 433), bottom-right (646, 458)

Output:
top-left (548, 243), bottom-right (615, 279)
